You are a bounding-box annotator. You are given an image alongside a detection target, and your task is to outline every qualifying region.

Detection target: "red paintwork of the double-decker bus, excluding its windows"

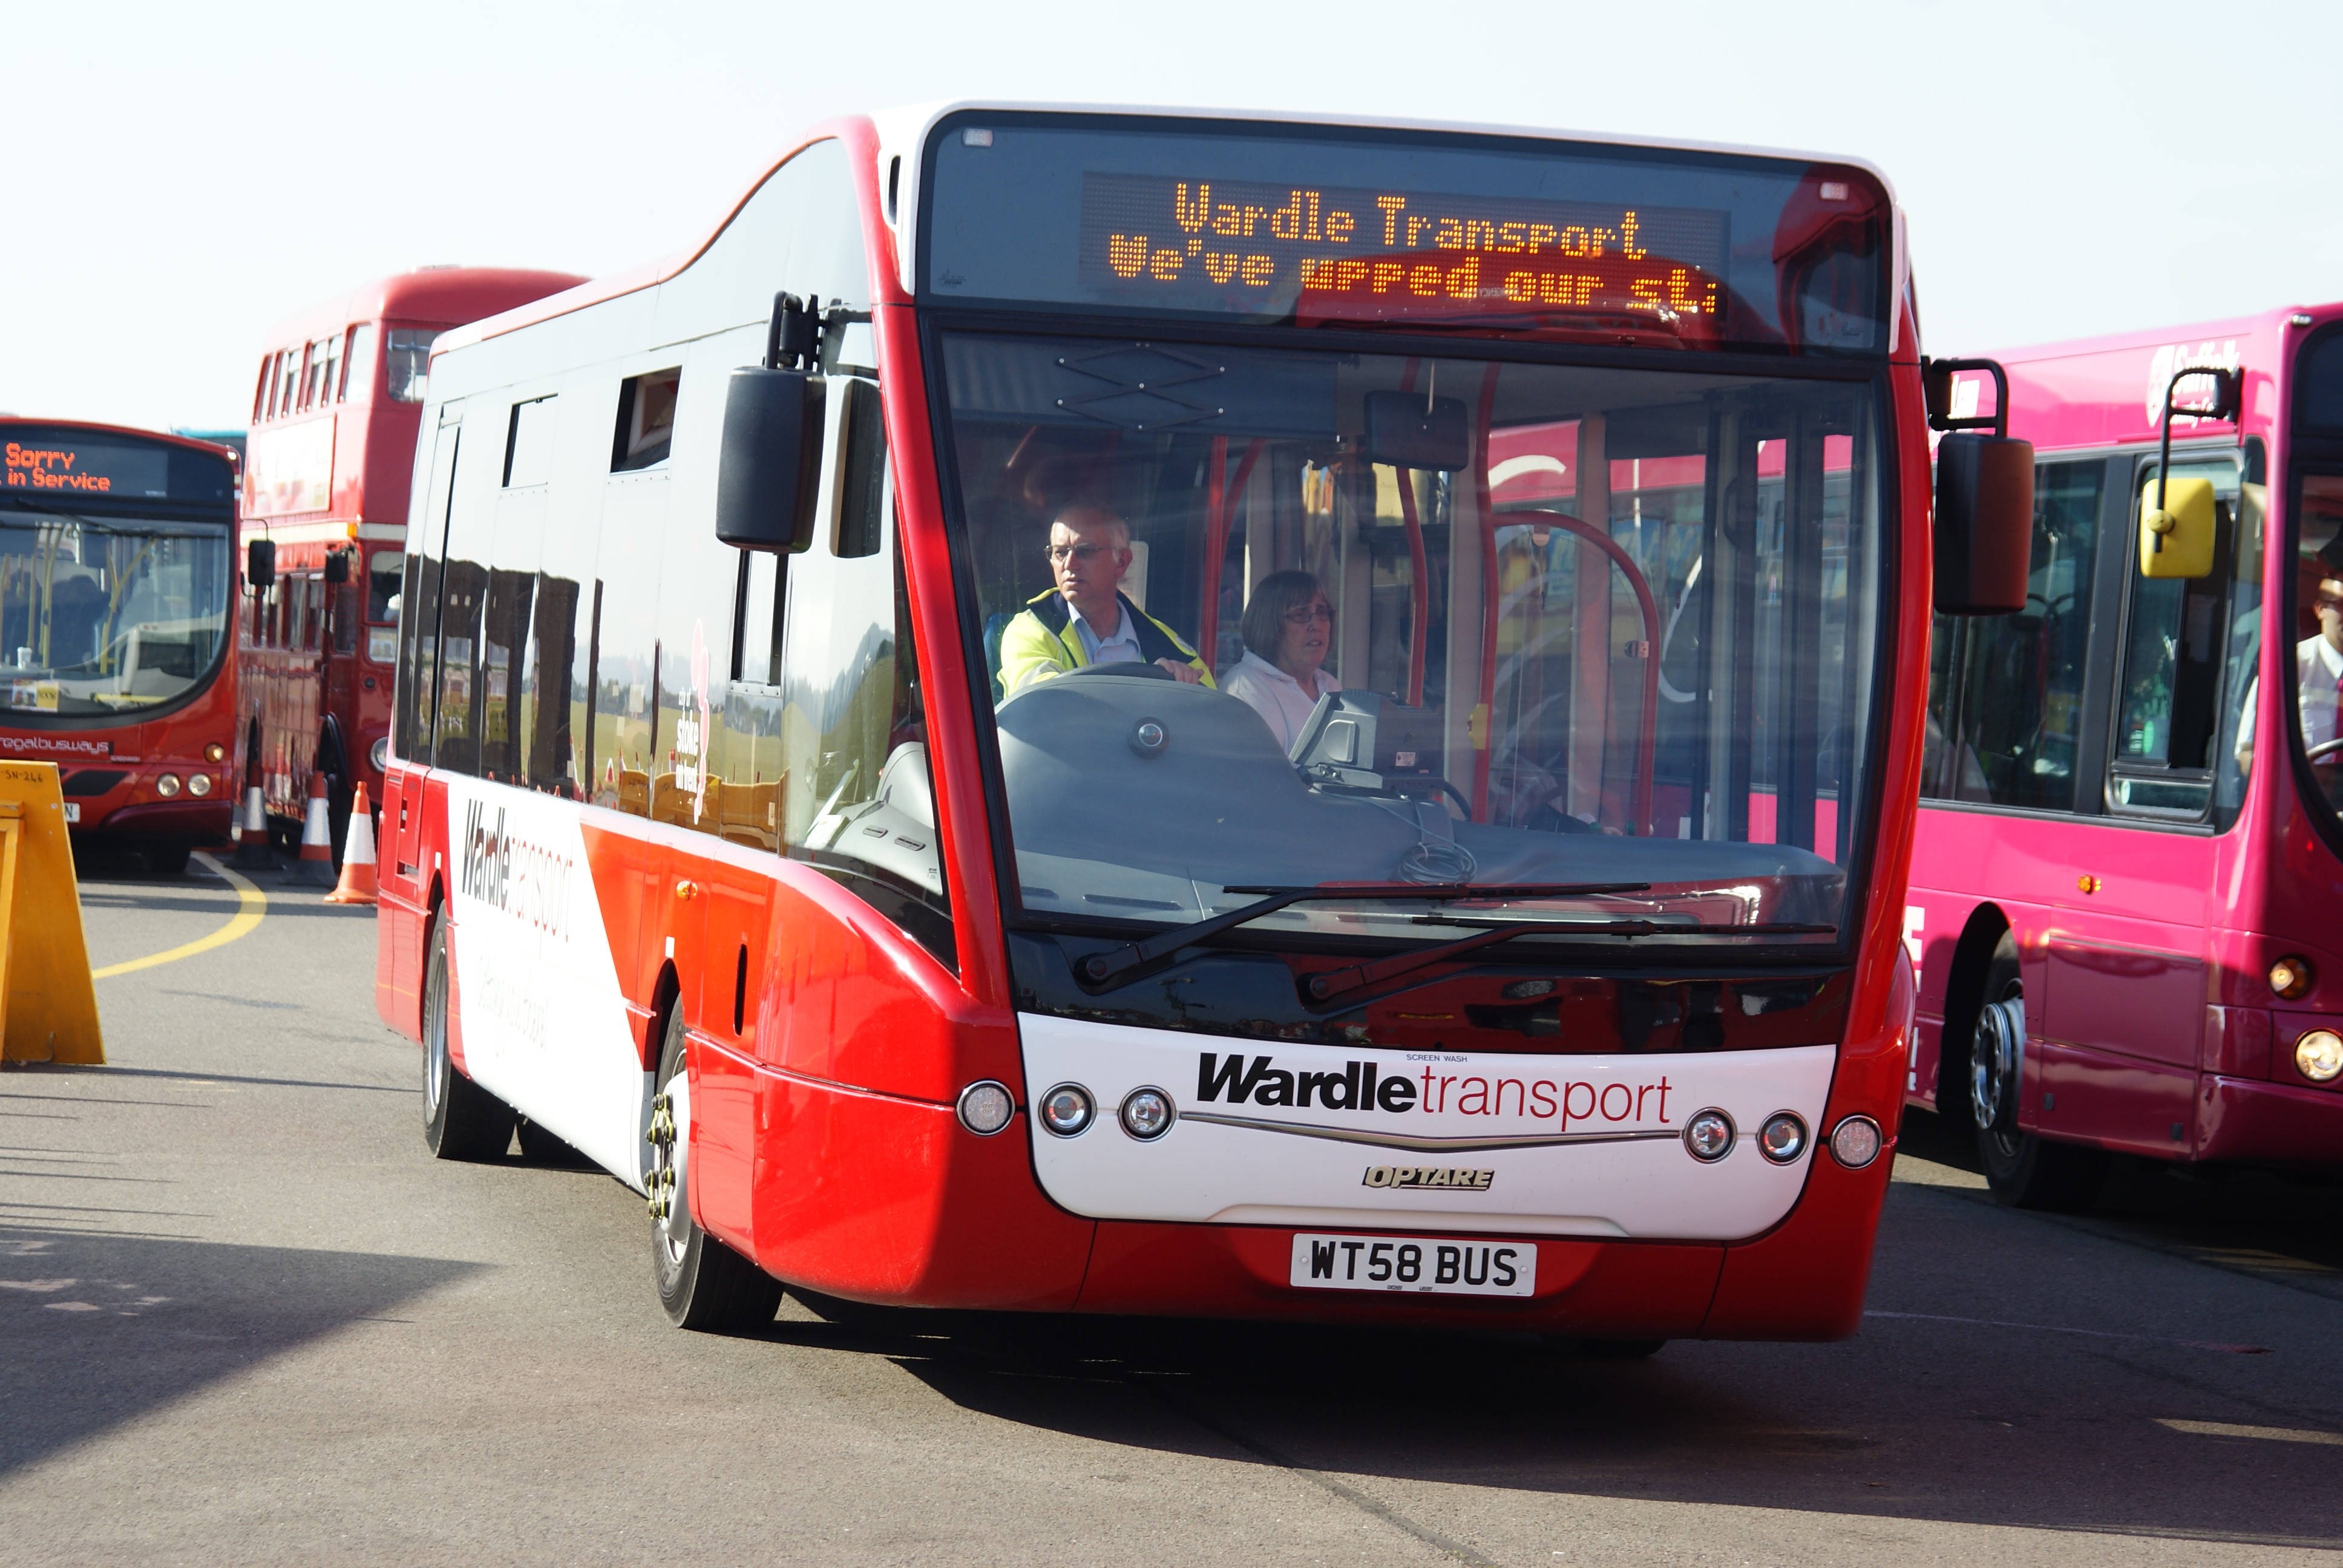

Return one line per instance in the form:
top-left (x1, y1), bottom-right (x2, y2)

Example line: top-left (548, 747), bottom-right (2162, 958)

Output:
top-left (237, 267), bottom-right (583, 825)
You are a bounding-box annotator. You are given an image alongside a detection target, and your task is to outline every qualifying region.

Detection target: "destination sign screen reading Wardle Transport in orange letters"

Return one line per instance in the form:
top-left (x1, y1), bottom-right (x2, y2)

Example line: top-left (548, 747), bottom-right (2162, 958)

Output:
top-left (919, 110), bottom-right (1891, 354)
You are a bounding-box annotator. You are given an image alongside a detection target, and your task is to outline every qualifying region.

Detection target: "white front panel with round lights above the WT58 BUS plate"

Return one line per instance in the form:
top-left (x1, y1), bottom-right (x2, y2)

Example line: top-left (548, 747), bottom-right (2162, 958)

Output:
top-left (1017, 1013), bottom-right (1837, 1242)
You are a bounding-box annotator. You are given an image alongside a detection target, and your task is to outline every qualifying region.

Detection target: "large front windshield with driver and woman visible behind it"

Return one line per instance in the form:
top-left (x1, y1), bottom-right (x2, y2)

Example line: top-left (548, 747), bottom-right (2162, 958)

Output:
top-left (944, 333), bottom-right (1889, 949)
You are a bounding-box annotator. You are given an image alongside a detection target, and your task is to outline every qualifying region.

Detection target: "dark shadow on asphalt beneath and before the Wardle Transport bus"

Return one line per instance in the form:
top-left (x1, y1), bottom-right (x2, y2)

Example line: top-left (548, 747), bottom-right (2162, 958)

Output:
top-left (766, 1266), bottom-right (2343, 1549)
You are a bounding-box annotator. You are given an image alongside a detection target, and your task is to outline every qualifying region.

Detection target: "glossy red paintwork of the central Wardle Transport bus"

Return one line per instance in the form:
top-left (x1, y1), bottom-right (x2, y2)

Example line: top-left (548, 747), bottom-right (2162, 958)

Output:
top-left (377, 120), bottom-right (1931, 1338)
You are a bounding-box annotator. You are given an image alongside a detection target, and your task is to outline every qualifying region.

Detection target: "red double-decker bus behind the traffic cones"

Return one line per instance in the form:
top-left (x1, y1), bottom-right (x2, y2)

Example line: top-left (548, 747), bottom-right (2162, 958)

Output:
top-left (237, 267), bottom-right (583, 853)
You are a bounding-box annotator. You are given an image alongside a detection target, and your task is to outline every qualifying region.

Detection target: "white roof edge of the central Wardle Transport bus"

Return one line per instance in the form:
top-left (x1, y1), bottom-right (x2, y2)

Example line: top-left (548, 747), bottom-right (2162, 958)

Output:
top-left (431, 99), bottom-right (1905, 356)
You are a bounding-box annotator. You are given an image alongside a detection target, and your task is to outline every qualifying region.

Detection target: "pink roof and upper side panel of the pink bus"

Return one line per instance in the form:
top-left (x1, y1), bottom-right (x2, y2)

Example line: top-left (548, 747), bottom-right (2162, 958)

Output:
top-left (1959, 302), bottom-right (2343, 450)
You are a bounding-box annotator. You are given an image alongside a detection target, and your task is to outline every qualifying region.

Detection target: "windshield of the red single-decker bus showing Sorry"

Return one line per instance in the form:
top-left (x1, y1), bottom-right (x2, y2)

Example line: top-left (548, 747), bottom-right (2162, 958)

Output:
top-left (0, 511), bottom-right (229, 724)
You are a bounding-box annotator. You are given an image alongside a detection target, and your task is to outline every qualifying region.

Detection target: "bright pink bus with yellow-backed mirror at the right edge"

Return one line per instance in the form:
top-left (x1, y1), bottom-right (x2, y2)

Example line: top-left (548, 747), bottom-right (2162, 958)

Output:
top-left (1905, 305), bottom-right (2343, 1207)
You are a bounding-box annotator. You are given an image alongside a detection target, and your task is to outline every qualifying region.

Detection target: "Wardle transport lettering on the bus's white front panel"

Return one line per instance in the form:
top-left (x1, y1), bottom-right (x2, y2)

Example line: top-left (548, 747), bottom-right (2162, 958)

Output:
top-left (1195, 1050), bottom-right (1675, 1132)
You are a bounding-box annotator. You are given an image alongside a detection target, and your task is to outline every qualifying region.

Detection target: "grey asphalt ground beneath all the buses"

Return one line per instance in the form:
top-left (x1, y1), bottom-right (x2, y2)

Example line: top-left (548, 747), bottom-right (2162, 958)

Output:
top-left (0, 848), bottom-right (2343, 1568)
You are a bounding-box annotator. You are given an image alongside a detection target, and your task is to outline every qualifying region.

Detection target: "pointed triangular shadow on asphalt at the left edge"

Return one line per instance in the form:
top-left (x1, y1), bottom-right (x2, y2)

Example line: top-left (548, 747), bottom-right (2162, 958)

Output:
top-left (0, 1223), bottom-right (480, 1477)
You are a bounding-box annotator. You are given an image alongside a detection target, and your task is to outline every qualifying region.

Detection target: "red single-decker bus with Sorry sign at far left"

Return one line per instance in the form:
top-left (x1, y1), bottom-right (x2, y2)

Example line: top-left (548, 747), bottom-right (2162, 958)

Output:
top-left (0, 417), bottom-right (237, 874)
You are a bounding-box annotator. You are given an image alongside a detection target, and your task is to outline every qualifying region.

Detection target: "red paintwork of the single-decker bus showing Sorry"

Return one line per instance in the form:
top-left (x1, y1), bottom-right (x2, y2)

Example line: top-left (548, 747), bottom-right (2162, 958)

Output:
top-left (0, 420), bottom-right (244, 849)
